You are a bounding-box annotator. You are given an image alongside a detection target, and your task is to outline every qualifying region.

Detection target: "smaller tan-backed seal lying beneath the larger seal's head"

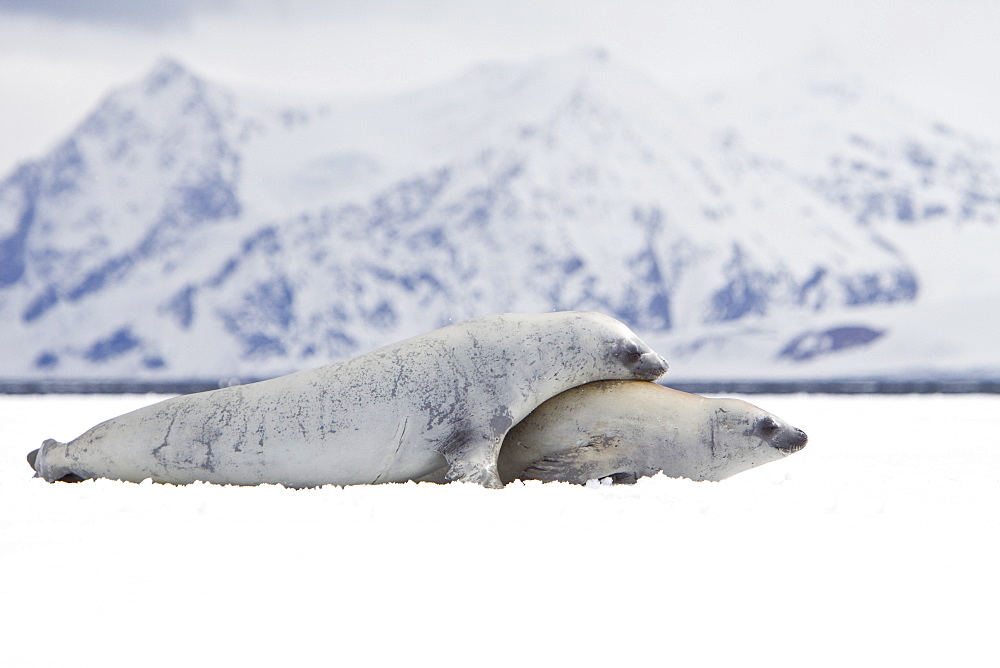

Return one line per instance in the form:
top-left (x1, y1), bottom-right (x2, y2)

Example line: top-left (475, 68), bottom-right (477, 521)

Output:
top-left (499, 381), bottom-right (807, 484)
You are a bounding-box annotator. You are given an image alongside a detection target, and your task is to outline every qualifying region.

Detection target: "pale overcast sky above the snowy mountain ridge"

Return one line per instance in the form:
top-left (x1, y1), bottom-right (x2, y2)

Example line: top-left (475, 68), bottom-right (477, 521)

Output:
top-left (0, 0), bottom-right (1000, 175)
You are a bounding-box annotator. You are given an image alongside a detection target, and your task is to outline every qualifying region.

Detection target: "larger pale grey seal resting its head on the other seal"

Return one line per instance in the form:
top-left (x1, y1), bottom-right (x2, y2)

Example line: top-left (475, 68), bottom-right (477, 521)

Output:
top-left (29, 312), bottom-right (667, 487)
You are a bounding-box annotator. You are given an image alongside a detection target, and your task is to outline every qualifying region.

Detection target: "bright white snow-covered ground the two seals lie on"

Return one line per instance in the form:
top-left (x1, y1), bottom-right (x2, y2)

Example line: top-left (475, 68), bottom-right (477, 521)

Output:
top-left (0, 395), bottom-right (1000, 666)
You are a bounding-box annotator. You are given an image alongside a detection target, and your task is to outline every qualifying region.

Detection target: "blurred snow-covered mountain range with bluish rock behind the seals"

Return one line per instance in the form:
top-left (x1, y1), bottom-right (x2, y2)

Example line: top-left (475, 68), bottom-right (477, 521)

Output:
top-left (0, 52), bottom-right (1000, 379)
